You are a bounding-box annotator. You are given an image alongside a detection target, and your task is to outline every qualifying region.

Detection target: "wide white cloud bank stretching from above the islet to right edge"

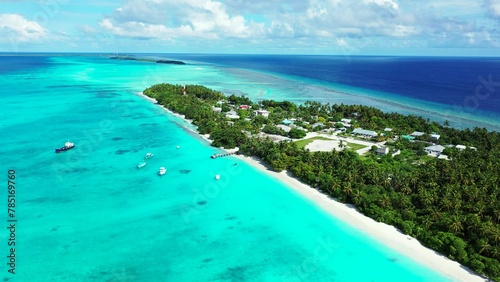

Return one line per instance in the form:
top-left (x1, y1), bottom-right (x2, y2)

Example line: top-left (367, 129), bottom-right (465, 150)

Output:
top-left (90, 0), bottom-right (500, 52)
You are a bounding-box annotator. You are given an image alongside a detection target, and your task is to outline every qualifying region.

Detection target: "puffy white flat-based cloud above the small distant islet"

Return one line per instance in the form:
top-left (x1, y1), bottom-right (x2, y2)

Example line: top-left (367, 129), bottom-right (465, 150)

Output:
top-left (100, 0), bottom-right (261, 40)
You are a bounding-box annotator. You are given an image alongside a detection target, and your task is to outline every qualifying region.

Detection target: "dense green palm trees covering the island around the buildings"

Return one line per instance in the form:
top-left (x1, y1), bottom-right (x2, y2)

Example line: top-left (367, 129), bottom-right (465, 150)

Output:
top-left (144, 84), bottom-right (500, 281)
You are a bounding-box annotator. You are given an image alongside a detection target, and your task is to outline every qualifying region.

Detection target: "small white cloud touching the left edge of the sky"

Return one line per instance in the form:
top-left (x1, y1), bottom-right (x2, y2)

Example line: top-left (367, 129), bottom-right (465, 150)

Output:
top-left (0, 14), bottom-right (47, 42)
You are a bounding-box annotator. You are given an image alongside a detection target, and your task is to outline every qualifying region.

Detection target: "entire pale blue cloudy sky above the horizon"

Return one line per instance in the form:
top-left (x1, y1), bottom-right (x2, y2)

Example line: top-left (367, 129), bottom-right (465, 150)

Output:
top-left (0, 0), bottom-right (500, 56)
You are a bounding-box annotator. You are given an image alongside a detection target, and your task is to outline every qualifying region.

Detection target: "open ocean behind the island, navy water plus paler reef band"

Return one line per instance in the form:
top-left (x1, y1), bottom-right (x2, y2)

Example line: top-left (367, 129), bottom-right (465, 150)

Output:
top-left (156, 54), bottom-right (500, 130)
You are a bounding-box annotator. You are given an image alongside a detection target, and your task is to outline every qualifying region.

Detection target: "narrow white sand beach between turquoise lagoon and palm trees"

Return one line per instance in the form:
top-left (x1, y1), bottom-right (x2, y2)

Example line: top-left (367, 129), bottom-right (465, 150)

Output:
top-left (138, 92), bottom-right (488, 282)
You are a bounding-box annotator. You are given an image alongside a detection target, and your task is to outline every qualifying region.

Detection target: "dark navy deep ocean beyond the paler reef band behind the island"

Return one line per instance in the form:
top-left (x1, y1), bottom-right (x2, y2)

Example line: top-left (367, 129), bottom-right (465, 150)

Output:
top-left (164, 54), bottom-right (500, 113)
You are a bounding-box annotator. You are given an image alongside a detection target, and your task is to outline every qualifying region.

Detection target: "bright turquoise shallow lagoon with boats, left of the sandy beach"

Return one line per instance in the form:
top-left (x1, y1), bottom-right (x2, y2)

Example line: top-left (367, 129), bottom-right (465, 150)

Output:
top-left (0, 57), bottom-right (456, 281)
